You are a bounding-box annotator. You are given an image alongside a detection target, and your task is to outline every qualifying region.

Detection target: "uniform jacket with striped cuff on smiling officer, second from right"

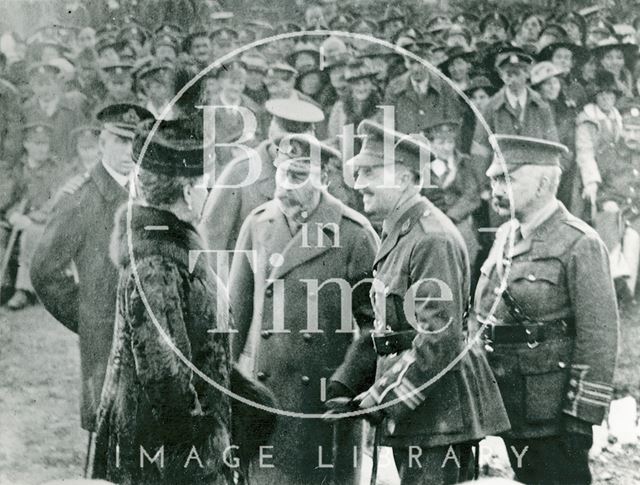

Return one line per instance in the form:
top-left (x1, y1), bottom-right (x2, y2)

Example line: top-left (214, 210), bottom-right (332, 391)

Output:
top-left (334, 197), bottom-right (509, 447)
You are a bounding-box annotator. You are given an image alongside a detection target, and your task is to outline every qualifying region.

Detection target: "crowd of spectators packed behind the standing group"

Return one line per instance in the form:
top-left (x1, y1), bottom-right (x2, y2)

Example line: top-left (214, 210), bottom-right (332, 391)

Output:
top-left (0, 0), bottom-right (640, 309)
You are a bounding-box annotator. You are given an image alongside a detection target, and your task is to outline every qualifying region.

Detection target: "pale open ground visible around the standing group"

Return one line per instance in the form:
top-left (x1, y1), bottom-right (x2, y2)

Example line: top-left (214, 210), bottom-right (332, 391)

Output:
top-left (0, 307), bottom-right (640, 485)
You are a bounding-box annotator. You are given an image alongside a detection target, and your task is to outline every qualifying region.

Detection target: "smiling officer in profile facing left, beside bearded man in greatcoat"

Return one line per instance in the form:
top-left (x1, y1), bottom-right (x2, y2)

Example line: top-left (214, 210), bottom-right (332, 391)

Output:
top-left (330, 121), bottom-right (509, 484)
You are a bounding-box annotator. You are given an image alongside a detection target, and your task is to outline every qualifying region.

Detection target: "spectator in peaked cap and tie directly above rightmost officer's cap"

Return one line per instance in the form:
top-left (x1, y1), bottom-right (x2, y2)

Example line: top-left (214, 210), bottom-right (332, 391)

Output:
top-left (471, 47), bottom-right (558, 189)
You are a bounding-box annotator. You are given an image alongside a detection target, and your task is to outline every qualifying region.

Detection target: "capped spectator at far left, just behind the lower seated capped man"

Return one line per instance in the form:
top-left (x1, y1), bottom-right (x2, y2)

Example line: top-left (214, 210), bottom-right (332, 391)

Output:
top-left (22, 64), bottom-right (86, 161)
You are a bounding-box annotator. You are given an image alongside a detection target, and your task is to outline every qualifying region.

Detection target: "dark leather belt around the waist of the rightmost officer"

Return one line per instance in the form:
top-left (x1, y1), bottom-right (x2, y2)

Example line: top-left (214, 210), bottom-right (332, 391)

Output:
top-left (482, 320), bottom-right (573, 350)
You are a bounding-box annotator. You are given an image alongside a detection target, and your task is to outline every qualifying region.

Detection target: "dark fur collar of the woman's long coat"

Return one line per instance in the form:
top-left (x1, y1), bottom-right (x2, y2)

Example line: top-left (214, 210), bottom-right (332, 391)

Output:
top-left (110, 203), bottom-right (209, 278)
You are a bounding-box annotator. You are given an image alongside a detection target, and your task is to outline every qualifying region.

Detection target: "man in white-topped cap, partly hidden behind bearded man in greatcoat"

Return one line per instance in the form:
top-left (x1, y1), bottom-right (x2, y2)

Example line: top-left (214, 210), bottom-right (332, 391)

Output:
top-left (202, 99), bottom-right (324, 251)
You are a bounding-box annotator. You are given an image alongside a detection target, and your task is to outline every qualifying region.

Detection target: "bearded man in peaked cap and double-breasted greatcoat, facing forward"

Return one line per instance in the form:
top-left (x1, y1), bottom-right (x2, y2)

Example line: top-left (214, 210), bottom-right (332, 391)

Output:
top-left (229, 134), bottom-right (378, 484)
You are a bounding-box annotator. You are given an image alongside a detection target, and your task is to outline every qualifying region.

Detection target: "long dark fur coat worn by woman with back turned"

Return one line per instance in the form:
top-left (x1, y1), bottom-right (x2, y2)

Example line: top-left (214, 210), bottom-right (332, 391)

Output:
top-left (94, 205), bottom-right (231, 485)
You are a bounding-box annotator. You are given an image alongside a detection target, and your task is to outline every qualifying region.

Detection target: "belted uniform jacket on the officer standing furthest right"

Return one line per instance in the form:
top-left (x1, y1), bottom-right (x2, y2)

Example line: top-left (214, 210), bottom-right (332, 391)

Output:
top-left (475, 204), bottom-right (618, 438)
